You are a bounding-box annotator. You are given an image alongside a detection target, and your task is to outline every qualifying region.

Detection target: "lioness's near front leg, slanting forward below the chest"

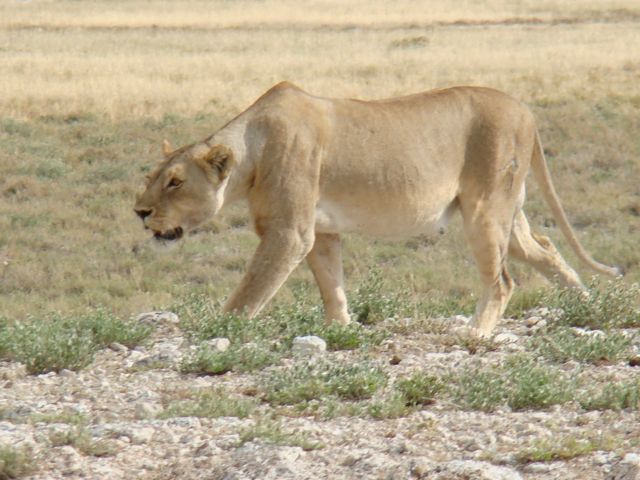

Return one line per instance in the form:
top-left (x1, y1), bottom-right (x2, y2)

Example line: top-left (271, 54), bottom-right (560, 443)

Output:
top-left (224, 229), bottom-right (314, 317)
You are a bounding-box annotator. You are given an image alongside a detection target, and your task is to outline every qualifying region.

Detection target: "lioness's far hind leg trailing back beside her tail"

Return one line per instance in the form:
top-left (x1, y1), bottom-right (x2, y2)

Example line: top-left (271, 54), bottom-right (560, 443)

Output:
top-left (509, 210), bottom-right (585, 290)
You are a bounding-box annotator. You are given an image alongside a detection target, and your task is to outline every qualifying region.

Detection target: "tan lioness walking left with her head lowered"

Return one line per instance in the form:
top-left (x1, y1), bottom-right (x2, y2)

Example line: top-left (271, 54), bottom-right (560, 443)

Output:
top-left (135, 82), bottom-right (620, 336)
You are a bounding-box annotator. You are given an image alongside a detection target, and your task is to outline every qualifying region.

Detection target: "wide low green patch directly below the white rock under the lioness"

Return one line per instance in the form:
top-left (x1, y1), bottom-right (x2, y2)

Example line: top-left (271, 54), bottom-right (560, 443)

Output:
top-left (261, 361), bottom-right (387, 405)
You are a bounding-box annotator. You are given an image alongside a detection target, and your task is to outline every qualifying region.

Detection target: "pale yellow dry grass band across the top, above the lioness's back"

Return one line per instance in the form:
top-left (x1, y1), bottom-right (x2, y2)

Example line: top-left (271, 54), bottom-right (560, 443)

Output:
top-left (0, 1), bottom-right (640, 119)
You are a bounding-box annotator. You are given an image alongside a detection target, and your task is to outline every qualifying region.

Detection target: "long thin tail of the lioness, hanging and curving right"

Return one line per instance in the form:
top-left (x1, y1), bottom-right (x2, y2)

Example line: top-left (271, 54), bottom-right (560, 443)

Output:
top-left (531, 132), bottom-right (623, 277)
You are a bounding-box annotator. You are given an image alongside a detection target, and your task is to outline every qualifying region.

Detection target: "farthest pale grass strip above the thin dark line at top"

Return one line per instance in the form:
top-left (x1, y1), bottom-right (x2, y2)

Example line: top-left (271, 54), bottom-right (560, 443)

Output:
top-left (0, 0), bottom-right (637, 29)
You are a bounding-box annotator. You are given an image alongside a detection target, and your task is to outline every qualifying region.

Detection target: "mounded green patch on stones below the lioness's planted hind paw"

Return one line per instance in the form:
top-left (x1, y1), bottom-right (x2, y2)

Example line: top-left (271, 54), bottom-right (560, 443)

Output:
top-left (446, 355), bottom-right (572, 412)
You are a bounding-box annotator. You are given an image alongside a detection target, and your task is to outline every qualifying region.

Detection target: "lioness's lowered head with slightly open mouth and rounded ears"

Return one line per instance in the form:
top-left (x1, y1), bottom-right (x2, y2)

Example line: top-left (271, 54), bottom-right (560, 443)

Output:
top-left (134, 140), bottom-right (234, 240)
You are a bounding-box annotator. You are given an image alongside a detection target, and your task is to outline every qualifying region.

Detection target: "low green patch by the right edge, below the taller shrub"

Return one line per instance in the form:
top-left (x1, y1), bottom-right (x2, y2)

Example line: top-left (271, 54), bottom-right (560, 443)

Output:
top-left (529, 327), bottom-right (634, 364)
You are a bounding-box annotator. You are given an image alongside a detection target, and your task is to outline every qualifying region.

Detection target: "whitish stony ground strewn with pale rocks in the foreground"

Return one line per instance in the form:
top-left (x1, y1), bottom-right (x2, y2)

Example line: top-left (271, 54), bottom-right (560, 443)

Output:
top-left (0, 315), bottom-right (640, 480)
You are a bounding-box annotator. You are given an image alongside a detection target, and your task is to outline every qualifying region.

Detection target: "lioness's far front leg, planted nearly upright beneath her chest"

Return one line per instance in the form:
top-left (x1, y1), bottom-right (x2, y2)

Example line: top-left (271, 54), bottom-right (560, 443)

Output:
top-left (307, 233), bottom-right (351, 325)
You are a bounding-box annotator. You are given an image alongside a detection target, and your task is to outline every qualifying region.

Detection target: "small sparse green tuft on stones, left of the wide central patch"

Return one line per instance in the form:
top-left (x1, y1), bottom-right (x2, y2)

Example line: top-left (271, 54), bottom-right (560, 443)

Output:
top-left (159, 389), bottom-right (258, 419)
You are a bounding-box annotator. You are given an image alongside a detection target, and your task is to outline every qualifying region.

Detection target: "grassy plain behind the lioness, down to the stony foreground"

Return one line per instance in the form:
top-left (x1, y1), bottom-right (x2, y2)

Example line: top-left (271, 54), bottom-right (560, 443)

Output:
top-left (0, 0), bottom-right (640, 318)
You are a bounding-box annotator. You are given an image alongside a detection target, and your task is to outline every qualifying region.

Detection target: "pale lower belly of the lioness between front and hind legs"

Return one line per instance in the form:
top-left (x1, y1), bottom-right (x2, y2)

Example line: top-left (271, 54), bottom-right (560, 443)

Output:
top-left (316, 199), bottom-right (455, 238)
